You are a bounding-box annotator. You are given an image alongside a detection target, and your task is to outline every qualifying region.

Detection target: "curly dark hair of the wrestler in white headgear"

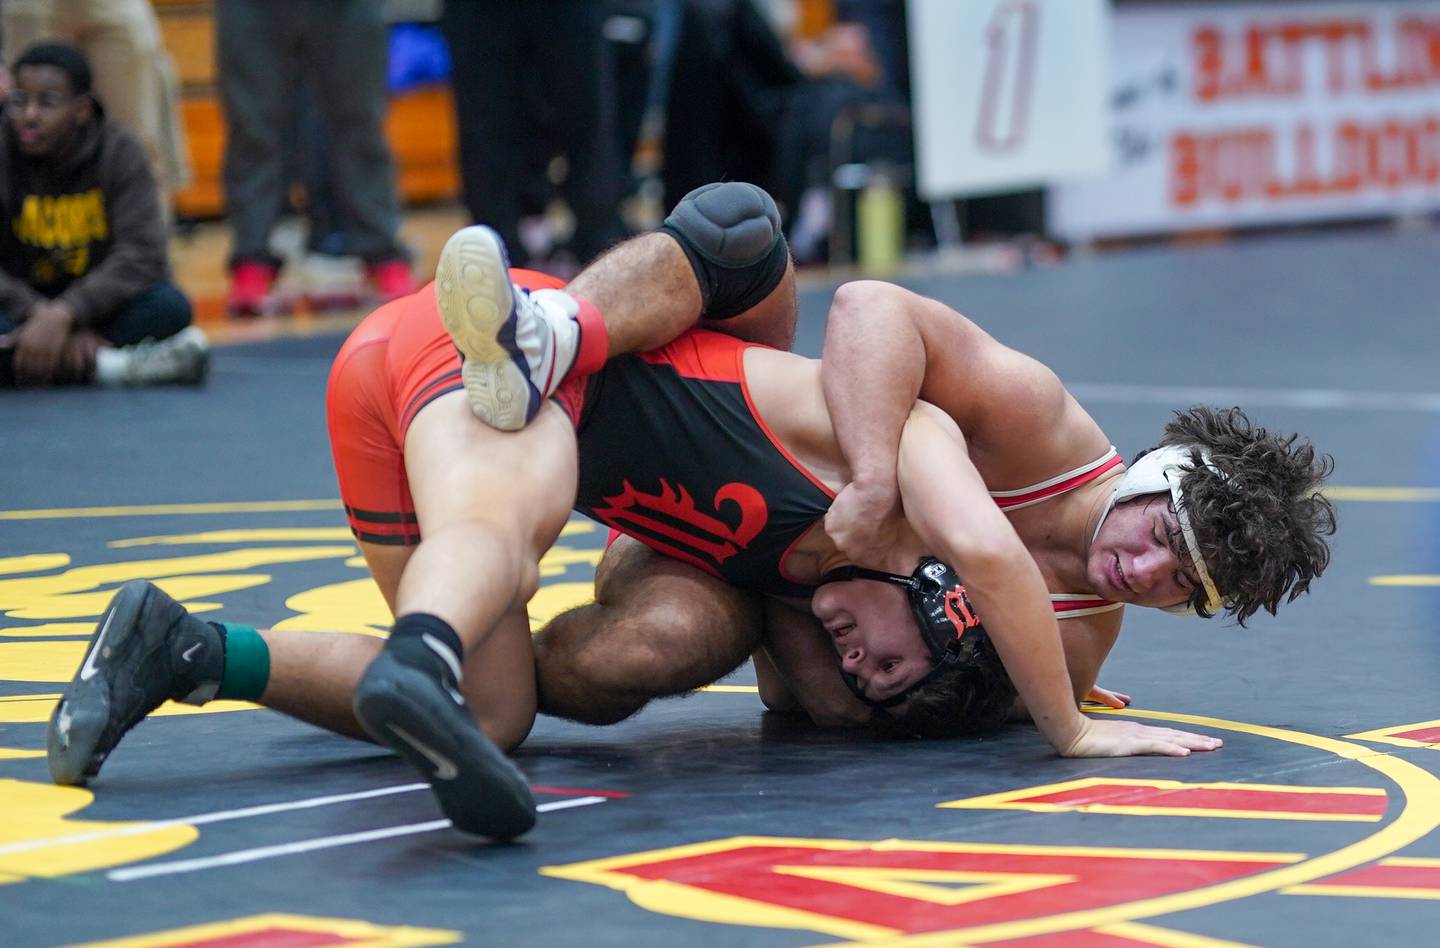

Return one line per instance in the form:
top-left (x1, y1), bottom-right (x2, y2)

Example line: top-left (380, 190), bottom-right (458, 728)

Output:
top-left (1161, 405), bottom-right (1335, 625)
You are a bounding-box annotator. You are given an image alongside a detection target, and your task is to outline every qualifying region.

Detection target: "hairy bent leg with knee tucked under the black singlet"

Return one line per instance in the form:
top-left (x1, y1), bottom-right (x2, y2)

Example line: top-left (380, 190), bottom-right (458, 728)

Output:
top-left (534, 537), bottom-right (762, 725)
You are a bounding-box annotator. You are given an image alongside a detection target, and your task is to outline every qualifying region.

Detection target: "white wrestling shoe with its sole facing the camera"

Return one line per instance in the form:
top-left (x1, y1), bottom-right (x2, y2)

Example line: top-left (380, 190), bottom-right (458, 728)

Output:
top-left (435, 226), bottom-right (580, 431)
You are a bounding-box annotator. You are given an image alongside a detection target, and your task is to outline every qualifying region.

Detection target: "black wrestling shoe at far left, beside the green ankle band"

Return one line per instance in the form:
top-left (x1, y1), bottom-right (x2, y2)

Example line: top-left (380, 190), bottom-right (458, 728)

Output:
top-left (45, 579), bottom-right (225, 785)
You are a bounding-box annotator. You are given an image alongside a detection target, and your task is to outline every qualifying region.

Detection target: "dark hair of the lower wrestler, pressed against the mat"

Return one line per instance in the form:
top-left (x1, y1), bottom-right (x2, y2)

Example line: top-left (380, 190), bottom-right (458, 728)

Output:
top-left (876, 628), bottom-right (1015, 738)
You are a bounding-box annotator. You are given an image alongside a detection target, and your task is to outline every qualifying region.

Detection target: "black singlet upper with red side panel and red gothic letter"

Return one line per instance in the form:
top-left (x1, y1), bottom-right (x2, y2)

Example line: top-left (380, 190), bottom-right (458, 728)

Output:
top-left (576, 330), bottom-right (832, 598)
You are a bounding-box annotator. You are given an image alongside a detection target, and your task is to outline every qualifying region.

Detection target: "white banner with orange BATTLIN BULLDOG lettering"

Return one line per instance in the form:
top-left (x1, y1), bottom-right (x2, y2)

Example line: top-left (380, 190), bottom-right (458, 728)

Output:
top-left (1048, 0), bottom-right (1440, 239)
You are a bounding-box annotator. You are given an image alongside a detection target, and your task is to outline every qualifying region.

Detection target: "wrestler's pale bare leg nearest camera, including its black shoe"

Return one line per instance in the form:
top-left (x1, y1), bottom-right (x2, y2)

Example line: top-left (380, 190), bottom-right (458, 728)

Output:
top-left (342, 392), bottom-right (576, 839)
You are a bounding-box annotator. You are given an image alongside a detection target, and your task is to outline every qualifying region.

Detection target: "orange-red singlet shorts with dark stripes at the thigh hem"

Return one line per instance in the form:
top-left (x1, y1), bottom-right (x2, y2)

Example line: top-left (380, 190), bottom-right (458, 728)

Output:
top-left (325, 269), bottom-right (573, 546)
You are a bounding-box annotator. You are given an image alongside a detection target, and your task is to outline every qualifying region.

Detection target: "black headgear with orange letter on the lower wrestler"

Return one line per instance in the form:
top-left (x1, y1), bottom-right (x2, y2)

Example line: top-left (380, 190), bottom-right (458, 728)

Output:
top-left (821, 556), bottom-right (985, 709)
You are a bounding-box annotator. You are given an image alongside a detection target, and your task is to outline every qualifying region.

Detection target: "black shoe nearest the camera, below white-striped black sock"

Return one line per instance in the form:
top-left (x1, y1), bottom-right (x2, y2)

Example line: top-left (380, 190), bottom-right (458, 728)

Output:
top-left (354, 650), bottom-right (536, 840)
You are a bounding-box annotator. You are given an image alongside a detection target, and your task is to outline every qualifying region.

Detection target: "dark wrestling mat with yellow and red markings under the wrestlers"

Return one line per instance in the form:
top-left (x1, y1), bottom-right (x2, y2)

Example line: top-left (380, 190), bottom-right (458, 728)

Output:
top-left (0, 224), bottom-right (1440, 948)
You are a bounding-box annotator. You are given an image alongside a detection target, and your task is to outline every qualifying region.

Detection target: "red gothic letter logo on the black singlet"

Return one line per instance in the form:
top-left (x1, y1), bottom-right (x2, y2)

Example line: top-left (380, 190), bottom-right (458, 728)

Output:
top-left (595, 480), bottom-right (770, 576)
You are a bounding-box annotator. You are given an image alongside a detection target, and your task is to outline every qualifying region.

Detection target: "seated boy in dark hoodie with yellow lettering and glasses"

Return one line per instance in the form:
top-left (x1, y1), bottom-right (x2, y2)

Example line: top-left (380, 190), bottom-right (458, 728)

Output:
top-left (0, 43), bottom-right (209, 386)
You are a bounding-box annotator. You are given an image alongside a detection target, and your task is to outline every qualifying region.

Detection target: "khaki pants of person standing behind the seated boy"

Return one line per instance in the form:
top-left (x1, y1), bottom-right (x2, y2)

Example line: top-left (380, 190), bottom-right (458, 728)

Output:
top-left (0, 0), bottom-right (192, 219)
